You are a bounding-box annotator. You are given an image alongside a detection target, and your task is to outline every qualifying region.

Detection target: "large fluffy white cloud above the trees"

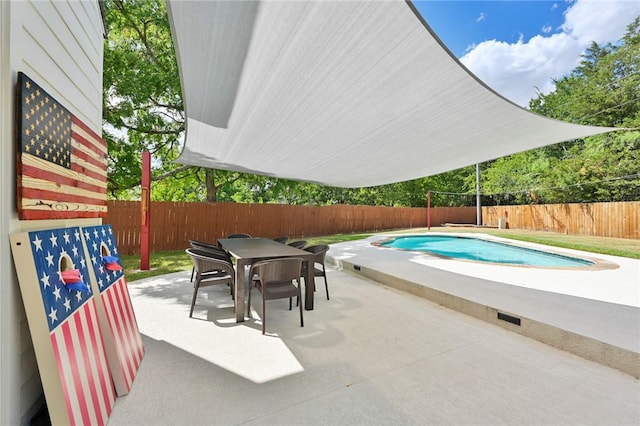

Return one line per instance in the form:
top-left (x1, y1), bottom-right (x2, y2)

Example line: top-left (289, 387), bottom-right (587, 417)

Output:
top-left (460, 0), bottom-right (640, 106)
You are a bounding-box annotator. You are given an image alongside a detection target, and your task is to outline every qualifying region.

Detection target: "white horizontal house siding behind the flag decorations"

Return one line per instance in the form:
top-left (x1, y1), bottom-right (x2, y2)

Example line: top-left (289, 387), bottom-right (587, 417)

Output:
top-left (0, 0), bottom-right (104, 425)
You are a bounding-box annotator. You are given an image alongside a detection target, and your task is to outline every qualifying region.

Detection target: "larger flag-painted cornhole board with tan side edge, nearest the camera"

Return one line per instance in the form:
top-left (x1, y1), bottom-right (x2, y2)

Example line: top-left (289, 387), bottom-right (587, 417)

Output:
top-left (10, 227), bottom-right (116, 425)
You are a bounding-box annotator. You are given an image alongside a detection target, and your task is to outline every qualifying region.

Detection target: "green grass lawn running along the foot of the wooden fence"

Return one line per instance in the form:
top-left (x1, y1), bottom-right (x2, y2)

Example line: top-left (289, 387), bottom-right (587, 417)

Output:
top-left (121, 227), bottom-right (640, 282)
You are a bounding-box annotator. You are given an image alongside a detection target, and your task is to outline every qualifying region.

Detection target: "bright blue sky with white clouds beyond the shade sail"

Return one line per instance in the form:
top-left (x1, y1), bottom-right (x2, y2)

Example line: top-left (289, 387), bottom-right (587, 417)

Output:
top-left (414, 0), bottom-right (640, 106)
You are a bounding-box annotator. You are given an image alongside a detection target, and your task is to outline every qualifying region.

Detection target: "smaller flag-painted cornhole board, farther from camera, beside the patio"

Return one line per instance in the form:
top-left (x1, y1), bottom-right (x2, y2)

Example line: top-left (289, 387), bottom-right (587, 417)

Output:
top-left (81, 225), bottom-right (144, 395)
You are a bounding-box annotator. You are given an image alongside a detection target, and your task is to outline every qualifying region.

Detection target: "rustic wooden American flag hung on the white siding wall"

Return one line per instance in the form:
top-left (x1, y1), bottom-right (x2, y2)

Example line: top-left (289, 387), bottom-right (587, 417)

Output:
top-left (16, 72), bottom-right (107, 220)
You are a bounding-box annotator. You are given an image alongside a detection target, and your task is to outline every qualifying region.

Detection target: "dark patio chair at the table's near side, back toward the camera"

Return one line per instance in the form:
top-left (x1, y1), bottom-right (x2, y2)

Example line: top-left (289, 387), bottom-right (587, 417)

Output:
top-left (247, 257), bottom-right (304, 334)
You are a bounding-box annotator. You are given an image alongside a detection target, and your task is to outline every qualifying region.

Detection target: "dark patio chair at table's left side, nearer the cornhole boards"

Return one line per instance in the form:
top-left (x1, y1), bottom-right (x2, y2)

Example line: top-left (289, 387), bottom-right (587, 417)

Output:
top-left (185, 249), bottom-right (236, 318)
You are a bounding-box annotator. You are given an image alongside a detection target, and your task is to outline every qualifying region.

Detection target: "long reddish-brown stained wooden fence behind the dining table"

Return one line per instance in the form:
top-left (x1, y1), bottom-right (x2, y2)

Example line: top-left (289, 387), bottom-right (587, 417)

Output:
top-left (105, 201), bottom-right (476, 255)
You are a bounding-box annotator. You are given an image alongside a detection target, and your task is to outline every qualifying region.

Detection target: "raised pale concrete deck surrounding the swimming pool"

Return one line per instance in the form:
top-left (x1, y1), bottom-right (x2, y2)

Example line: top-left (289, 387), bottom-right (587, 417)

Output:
top-left (328, 233), bottom-right (640, 377)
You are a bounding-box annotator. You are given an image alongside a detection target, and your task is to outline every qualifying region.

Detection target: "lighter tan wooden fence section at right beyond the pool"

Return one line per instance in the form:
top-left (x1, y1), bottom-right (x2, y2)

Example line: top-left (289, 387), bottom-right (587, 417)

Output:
top-left (482, 201), bottom-right (640, 239)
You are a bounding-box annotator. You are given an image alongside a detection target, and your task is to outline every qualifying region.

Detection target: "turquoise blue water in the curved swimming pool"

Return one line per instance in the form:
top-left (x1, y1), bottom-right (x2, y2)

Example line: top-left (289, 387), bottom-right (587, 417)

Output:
top-left (381, 235), bottom-right (594, 267)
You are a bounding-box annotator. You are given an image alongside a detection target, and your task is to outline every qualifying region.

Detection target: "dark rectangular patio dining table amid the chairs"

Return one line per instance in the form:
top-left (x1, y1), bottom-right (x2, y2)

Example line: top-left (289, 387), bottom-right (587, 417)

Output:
top-left (218, 238), bottom-right (315, 322)
